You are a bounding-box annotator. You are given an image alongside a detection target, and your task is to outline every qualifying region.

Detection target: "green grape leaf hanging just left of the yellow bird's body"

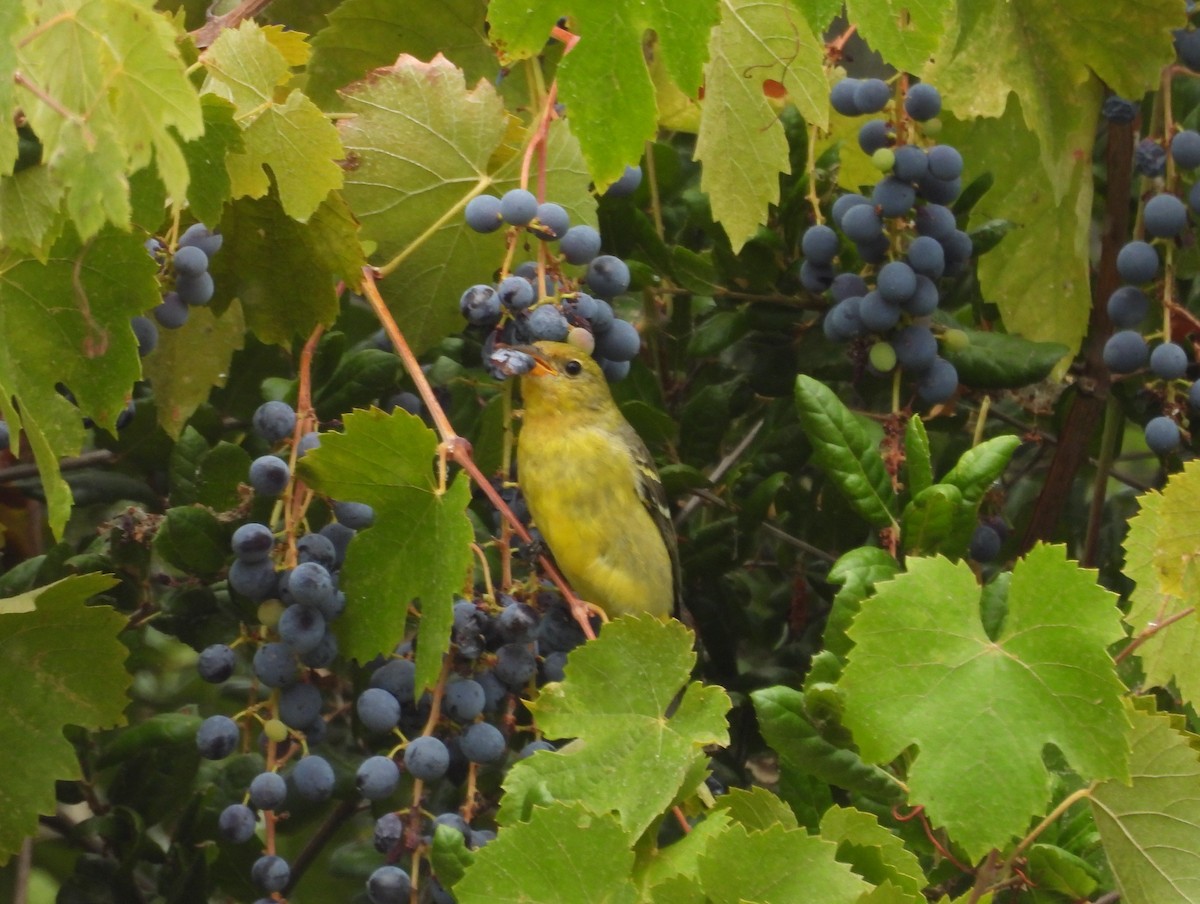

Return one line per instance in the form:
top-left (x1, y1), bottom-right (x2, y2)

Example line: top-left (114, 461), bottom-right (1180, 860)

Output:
top-left (299, 408), bottom-right (473, 694)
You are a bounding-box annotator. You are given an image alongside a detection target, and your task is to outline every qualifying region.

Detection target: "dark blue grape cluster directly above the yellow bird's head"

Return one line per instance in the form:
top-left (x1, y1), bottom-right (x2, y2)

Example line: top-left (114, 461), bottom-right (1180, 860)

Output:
top-left (458, 183), bottom-right (642, 381)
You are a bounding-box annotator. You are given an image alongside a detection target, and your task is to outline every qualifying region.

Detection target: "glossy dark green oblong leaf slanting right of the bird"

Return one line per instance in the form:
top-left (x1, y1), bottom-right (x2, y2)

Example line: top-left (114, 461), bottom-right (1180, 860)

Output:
top-left (796, 373), bottom-right (895, 527)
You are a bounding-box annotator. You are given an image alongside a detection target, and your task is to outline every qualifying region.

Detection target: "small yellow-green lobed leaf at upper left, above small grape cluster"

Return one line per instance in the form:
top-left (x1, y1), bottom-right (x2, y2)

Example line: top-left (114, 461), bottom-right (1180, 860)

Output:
top-left (202, 19), bottom-right (343, 222)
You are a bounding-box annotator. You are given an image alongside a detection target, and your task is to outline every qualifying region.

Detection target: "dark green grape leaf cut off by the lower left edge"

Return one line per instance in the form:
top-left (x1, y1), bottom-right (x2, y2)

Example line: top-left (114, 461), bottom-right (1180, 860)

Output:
top-left (0, 574), bottom-right (131, 864)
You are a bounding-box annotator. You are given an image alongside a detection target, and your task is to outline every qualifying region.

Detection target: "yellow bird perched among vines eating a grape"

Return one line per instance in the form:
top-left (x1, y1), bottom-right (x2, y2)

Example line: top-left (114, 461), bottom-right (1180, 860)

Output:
top-left (517, 342), bottom-right (679, 618)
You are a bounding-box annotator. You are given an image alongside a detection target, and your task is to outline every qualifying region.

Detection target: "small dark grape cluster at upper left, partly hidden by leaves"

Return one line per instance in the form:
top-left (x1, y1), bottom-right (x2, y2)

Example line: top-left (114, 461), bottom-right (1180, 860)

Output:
top-left (131, 223), bottom-right (223, 357)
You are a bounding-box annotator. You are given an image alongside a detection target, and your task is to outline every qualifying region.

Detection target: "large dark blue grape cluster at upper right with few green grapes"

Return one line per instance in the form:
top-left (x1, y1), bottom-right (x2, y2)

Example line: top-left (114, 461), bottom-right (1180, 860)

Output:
top-left (799, 78), bottom-right (972, 405)
